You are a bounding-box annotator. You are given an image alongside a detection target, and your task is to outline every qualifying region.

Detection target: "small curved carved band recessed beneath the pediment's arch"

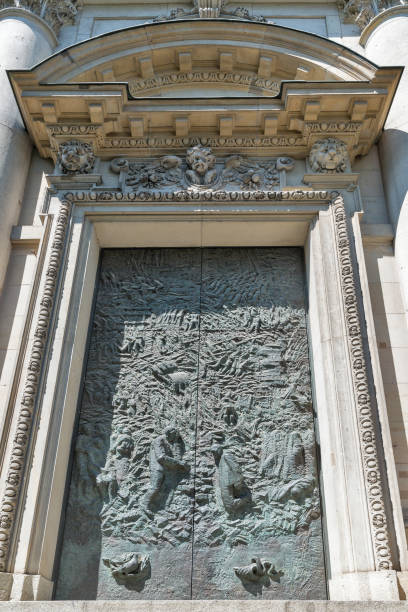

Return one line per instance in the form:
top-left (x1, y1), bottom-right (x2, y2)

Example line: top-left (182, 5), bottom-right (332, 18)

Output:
top-left (129, 70), bottom-right (280, 96)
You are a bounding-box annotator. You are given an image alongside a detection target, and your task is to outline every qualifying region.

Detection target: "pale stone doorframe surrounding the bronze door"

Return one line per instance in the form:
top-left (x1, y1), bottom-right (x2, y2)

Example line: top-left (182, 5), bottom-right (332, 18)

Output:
top-left (0, 186), bottom-right (407, 600)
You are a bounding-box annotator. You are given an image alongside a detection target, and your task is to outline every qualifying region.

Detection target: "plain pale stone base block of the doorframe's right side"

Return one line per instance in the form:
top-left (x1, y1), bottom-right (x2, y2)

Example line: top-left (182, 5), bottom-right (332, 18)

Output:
top-left (329, 571), bottom-right (401, 601)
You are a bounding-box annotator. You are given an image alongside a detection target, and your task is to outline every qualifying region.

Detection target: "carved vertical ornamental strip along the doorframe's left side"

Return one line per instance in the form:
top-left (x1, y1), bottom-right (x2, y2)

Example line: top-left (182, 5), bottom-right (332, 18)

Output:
top-left (0, 201), bottom-right (71, 572)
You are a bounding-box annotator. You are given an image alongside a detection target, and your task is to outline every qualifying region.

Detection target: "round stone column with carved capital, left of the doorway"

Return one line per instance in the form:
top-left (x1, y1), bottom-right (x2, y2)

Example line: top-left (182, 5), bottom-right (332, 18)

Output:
top-left (0, 0), bottom-right (78, 292)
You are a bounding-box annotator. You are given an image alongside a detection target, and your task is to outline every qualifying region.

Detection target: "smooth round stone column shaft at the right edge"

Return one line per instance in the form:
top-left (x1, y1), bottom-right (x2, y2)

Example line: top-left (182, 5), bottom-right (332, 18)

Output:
top-left (361, 6), bottom-right (408, 320)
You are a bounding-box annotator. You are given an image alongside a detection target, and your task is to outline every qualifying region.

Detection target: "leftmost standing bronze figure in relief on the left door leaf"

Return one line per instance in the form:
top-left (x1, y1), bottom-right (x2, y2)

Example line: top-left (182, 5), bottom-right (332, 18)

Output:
top-left (96, 432), bottom-right (134, 503)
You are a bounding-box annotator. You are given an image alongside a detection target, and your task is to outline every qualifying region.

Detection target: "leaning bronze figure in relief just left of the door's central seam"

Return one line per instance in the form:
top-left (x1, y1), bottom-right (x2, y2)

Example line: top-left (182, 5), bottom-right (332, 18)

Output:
top-left (145, 425), bottom-right (190, 510)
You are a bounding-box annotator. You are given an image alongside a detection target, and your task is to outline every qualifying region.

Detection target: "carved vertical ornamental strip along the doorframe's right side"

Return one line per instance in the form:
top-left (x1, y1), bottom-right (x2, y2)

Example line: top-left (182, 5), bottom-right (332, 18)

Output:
top-left (333, 196), bottom-right (392, 570)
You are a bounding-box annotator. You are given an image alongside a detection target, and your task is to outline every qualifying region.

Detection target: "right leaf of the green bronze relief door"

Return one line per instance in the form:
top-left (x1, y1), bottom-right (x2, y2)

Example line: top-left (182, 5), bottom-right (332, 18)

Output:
top-left (192, 248), bottom-right (326, 599)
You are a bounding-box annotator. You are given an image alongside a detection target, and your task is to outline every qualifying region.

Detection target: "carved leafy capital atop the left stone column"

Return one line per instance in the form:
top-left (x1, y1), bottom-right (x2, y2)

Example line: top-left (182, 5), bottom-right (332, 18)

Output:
top-left (0, 0), bottom-right (82, 36)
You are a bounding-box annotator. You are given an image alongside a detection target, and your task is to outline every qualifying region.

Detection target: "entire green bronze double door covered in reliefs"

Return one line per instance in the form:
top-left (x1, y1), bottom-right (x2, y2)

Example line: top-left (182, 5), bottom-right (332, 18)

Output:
top-left (56, 248), bottom-right (326, 599)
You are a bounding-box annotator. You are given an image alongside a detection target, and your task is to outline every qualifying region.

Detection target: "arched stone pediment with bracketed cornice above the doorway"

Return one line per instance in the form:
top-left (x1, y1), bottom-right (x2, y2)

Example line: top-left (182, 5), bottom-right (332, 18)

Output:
top-left (9, 19), bottom-right (401, 161)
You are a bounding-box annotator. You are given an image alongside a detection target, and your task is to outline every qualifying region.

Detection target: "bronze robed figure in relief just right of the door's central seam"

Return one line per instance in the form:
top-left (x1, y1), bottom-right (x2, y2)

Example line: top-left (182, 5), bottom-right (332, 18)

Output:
top-left (211, 444), bottom-right (251, 514)
